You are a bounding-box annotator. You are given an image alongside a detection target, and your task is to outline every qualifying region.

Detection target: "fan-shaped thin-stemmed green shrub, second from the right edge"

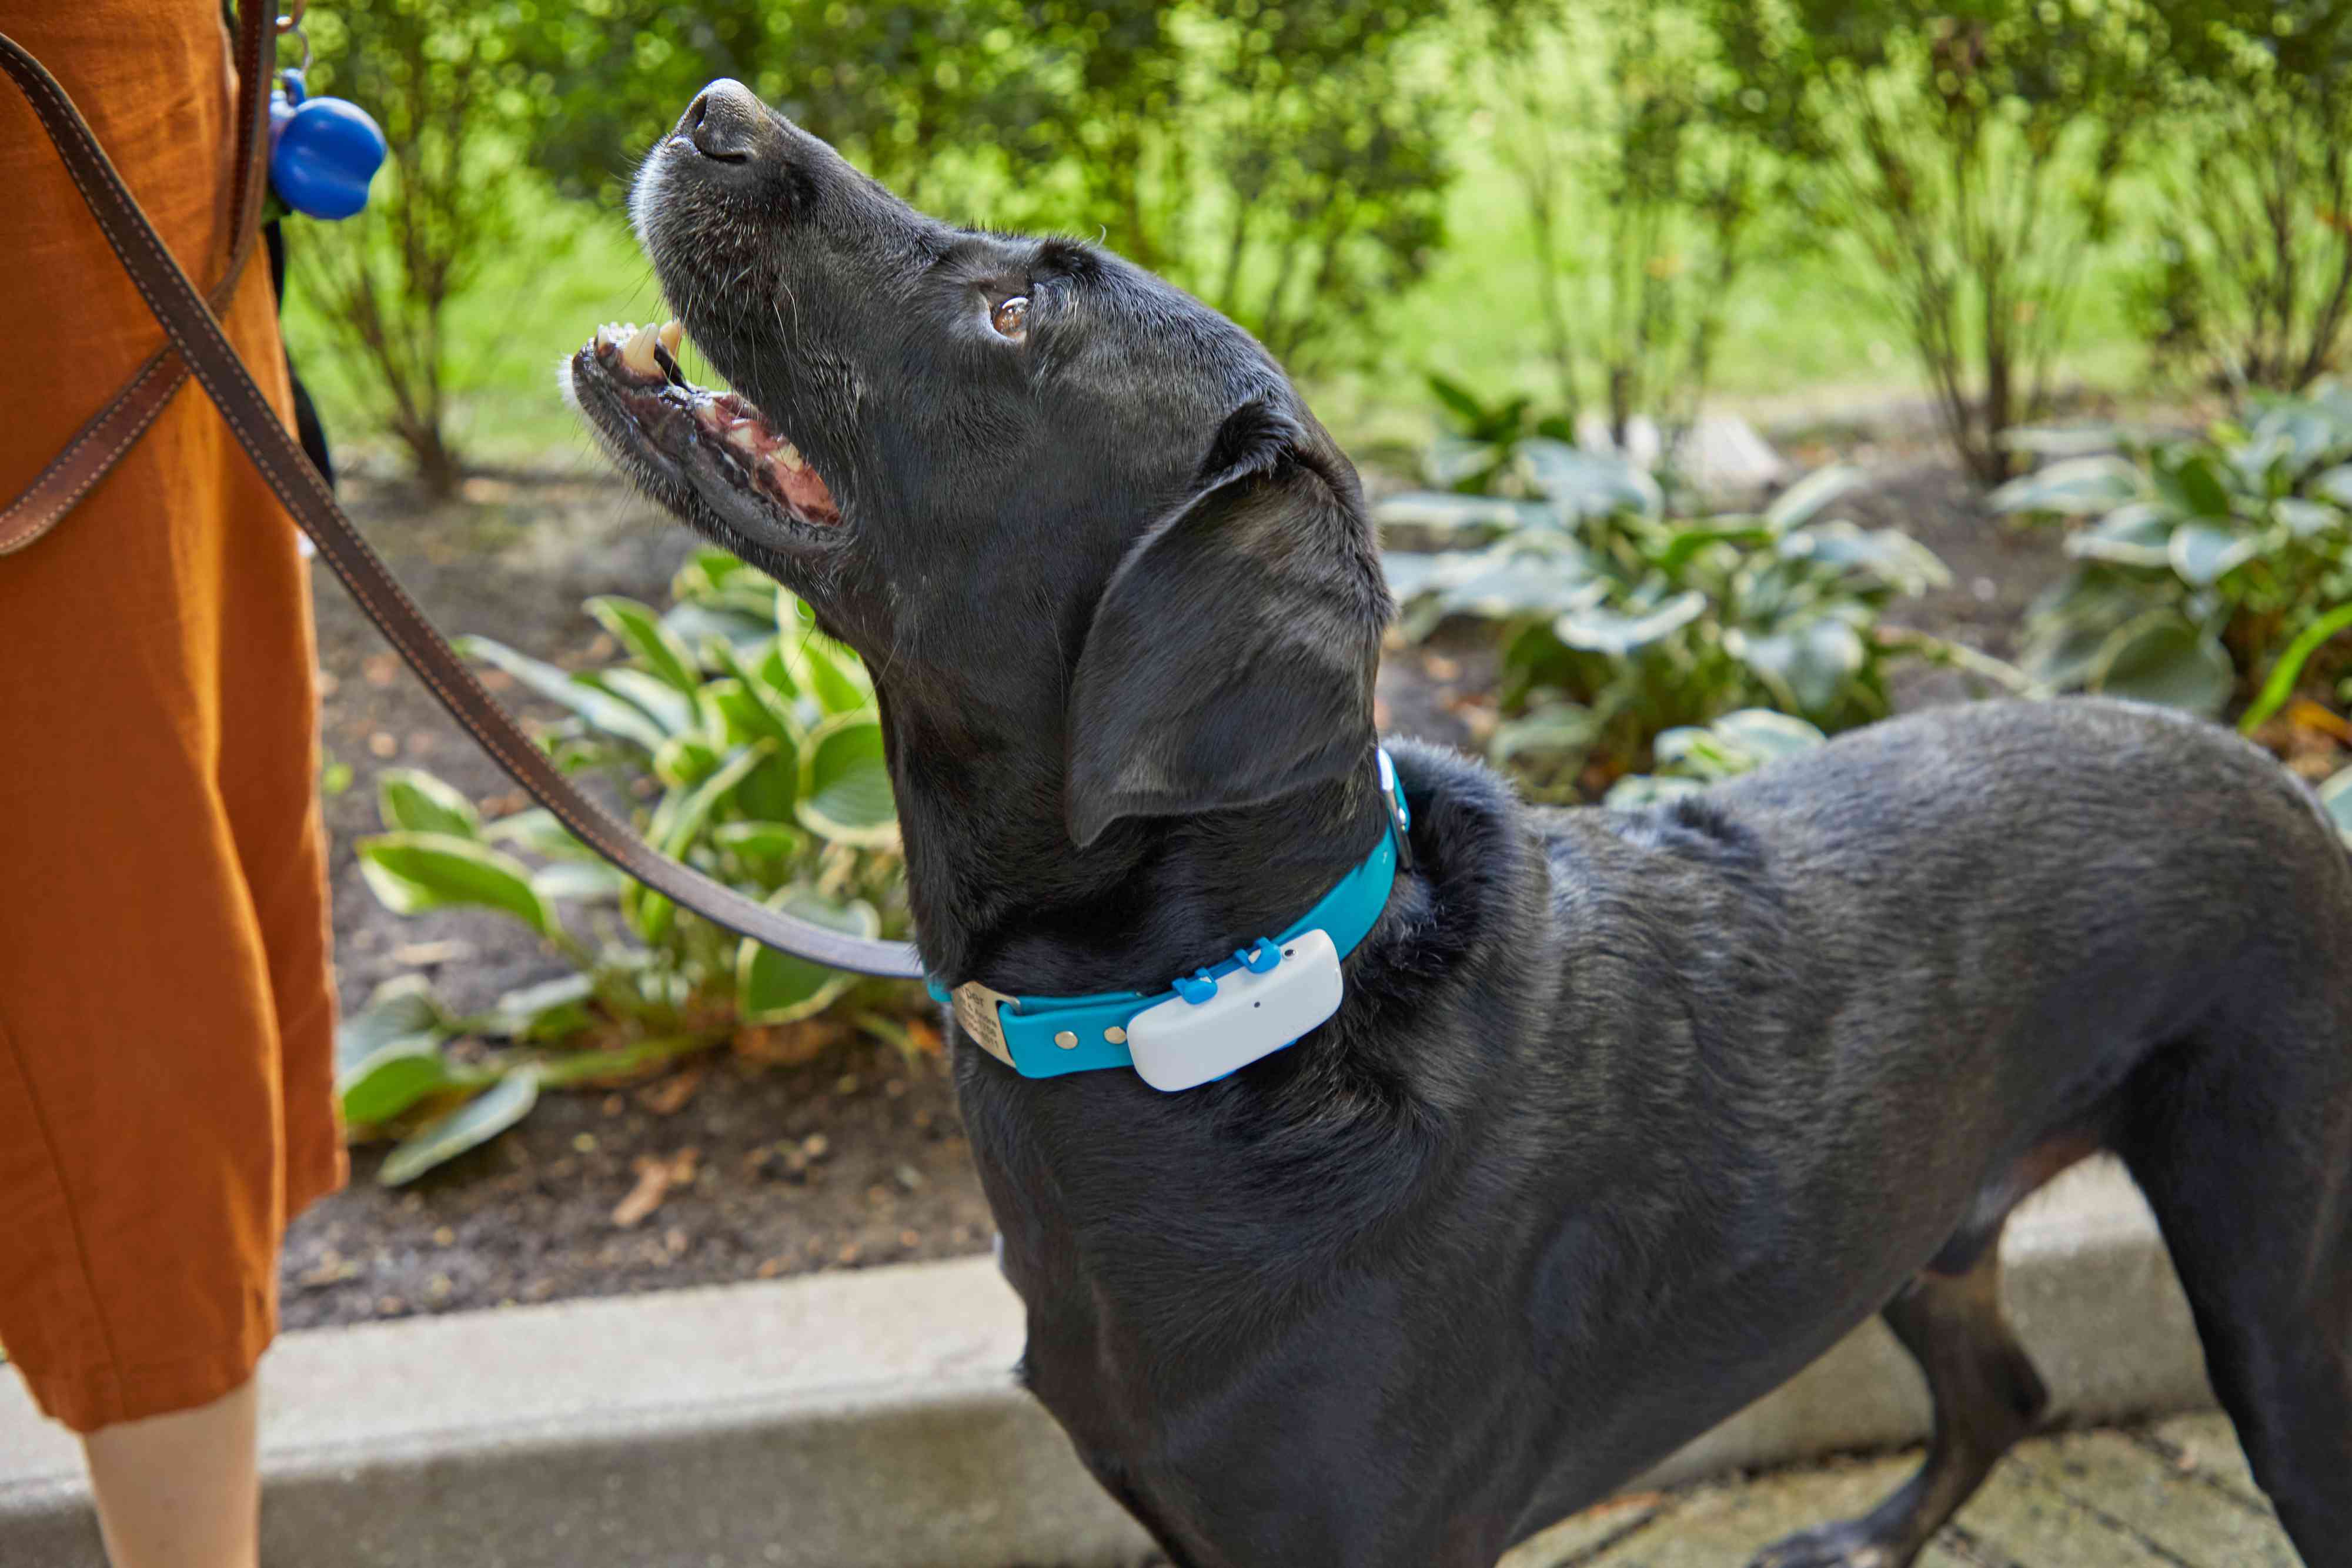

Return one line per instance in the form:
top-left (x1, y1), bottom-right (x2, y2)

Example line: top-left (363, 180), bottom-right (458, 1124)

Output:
top-left (1724, 0), bottom-right (2154, 484)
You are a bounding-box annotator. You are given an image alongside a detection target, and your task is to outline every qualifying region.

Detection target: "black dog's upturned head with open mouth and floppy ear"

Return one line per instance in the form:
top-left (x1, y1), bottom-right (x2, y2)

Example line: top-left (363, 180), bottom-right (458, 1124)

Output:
top-left (564, 82), bottom-right (1388, 844)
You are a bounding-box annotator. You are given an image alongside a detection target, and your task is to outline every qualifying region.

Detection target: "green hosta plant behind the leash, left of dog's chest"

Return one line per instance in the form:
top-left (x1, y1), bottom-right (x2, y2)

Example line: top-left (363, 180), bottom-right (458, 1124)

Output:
top-left (339, 550), bottom-right (913, 1182)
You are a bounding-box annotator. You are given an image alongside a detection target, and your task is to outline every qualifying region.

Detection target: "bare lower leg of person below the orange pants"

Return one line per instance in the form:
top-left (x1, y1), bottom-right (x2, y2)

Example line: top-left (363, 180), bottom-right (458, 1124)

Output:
top-left (82, 1378), bottom-right (261, 1568)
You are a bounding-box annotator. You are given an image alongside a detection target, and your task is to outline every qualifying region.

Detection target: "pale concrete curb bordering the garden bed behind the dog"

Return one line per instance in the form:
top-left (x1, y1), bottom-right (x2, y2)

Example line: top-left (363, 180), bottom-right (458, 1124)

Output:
top-left (0, 1166), bottom-right (2211, 1568)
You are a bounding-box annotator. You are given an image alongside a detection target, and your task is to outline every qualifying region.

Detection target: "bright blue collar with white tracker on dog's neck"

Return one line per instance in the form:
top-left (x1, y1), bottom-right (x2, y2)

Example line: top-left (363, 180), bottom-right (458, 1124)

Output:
top-left (927, 750), bottom-right (1411, 1088)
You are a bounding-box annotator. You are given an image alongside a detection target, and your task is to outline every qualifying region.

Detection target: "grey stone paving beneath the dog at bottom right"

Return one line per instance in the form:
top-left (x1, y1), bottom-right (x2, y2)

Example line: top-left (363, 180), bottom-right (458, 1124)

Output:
top-left (1501, 1415), bottom-right (2298, 1568)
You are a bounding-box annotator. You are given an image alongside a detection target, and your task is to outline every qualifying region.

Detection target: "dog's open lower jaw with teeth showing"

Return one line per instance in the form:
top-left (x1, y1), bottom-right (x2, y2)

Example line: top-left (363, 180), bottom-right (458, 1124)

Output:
top-left (572, 322), bottom-right (842, 531)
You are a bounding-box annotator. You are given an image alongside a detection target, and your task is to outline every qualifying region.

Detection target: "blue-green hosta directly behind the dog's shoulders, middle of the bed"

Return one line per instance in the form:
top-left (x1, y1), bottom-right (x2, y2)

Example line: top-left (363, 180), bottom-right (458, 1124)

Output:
top-left (1381, 437), bottom-right (1947, 797)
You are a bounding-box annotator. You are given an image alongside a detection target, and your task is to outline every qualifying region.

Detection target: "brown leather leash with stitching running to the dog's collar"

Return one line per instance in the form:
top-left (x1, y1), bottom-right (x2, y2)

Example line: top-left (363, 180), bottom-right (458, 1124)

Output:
top-left (0, 18), bottom-right (922, 978)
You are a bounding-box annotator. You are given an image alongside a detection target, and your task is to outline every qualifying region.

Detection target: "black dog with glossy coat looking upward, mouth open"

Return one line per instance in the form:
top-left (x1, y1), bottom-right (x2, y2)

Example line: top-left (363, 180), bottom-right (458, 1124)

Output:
top-left (567, 82), bottom-right (2352, 1568)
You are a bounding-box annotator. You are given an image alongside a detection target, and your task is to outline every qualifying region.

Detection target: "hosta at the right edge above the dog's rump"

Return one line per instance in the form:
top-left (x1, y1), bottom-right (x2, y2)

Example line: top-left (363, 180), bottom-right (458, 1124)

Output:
top-left (1992, 386), bottom-right (2352, 715)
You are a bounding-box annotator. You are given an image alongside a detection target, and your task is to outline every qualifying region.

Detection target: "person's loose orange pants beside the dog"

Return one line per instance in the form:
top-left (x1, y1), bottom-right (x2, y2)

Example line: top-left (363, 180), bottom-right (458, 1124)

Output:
top-left (0, 0), bottom-right (343, 1432)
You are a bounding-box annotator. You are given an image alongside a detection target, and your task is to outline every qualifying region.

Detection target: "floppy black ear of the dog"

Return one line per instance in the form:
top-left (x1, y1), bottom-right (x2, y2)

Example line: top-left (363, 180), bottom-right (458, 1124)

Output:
top-left (1068, 402), bottom-right (1390, 846)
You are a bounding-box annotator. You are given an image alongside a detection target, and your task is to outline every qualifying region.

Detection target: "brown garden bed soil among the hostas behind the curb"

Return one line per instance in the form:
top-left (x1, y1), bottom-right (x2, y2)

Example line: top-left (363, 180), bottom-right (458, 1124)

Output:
top-left (285, 432), bottom-right (2063, 1328)
